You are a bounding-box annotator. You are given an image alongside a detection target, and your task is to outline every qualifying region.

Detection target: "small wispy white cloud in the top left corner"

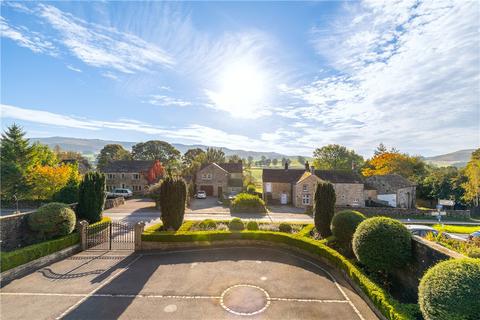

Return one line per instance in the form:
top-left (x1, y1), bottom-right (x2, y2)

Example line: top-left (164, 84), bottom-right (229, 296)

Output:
top-left (0, 17), bottom-right (57, 55)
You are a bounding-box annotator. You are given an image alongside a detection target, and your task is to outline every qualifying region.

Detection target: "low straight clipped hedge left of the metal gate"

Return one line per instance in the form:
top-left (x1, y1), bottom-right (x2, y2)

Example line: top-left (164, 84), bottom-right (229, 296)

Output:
top-left (0, 233), bottom-right (80, 272)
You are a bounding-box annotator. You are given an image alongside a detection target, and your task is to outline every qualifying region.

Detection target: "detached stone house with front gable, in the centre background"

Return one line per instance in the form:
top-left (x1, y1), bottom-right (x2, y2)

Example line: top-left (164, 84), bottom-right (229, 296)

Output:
top-left (195, 162), bottom-right (243, 197)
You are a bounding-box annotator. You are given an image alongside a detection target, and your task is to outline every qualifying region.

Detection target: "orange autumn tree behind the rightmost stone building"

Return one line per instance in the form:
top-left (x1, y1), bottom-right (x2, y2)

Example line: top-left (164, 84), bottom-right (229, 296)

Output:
top-left (362, 152), bottom-right (425, 181)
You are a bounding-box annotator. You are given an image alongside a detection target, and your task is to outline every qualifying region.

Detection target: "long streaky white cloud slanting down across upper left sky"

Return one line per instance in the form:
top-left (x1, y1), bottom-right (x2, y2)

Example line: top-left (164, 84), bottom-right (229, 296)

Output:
top-left (38, 4), bottom-right (174, 73)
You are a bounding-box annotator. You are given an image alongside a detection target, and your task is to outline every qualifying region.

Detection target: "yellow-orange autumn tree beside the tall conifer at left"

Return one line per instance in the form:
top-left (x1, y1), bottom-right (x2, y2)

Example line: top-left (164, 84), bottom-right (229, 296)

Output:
top-left (28, 164), bottom-right (80, 200)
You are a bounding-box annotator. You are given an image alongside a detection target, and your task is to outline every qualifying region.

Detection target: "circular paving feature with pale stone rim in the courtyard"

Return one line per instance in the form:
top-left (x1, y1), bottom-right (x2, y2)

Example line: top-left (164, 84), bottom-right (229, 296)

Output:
top-left (220, 284), bottom-right (270, 316)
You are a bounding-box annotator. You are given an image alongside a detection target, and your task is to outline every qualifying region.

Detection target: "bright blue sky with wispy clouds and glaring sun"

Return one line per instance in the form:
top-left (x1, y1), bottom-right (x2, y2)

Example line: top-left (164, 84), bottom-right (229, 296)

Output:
top-left (0, 0), bottom-right (480, 156)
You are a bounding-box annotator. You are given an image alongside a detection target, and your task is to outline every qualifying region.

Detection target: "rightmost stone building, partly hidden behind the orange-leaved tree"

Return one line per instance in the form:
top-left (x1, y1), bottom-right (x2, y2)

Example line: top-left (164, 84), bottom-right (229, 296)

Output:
top-left (365, 174), bottom-right (416, 209)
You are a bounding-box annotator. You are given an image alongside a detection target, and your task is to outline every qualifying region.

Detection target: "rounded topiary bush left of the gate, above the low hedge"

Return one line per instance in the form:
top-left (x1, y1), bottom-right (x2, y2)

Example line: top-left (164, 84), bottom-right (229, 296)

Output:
top-left (28, 202), bottom-right (77, 240)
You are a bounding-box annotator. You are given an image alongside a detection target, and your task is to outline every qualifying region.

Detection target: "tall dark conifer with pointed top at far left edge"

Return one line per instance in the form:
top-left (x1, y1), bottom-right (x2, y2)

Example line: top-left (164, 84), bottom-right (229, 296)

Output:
top-left (0, 124), bottom-right (34, 200)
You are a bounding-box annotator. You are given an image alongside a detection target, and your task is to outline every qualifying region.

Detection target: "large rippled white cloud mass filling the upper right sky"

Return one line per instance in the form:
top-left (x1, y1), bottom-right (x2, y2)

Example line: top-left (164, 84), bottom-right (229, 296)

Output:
top-left (280, 1), bottom-right (480, 153)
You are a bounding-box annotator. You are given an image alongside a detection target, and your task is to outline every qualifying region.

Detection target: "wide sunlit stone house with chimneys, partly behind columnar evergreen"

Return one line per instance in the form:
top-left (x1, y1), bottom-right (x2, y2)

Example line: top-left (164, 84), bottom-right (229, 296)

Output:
top-left (262, 165), bottom-right (365, 208)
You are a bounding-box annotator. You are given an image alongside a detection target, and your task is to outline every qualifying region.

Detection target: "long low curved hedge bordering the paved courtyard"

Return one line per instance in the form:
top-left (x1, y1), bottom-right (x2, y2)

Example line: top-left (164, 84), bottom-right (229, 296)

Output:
top-left (142, 225), bottom-right (415, 320)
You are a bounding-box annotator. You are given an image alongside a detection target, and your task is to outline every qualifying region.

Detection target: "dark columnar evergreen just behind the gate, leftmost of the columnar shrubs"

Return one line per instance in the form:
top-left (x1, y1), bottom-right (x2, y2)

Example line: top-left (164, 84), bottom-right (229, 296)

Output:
top-left (77, 172), bottom-right (107, 223)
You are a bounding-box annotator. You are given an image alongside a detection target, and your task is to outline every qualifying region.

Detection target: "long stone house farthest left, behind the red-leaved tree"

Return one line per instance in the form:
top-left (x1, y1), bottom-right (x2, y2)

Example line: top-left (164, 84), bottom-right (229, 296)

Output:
top-left (102, 160), bottom-right (165, 194)
